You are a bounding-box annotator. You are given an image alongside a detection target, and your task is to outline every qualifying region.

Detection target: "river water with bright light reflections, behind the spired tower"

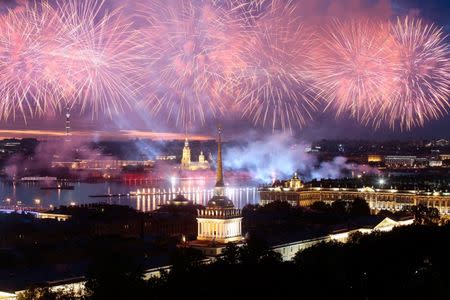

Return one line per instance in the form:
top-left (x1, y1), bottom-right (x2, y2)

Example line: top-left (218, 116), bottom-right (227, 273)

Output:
top-left (0, 182), bottom-right (259, 211)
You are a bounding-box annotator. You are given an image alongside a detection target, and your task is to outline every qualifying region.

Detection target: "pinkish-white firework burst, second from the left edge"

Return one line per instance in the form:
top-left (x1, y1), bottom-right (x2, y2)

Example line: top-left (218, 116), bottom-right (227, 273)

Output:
top-left (54, 0), bottom-right (139, 115)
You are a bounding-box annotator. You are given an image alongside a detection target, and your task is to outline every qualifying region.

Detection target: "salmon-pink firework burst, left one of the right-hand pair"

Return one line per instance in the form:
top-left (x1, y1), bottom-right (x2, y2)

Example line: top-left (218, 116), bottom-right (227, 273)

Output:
top-left (314, 19), bottom-right (393, 123)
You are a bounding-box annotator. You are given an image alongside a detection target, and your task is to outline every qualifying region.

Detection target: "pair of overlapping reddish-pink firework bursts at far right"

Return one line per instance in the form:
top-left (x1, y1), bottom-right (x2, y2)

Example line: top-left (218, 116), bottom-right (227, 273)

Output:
top-left (315, 17), bottom-right (450, 130)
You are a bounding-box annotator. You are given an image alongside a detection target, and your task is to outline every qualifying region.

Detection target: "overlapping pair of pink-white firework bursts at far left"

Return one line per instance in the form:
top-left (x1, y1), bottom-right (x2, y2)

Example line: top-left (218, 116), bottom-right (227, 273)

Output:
top-left (0, 0), bottom-right (138, 118)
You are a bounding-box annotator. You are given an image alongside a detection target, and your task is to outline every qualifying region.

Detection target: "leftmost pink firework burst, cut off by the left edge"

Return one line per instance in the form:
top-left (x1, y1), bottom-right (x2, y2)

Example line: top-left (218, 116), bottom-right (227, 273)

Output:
top-left (0, 3), bottom-right (60, 119)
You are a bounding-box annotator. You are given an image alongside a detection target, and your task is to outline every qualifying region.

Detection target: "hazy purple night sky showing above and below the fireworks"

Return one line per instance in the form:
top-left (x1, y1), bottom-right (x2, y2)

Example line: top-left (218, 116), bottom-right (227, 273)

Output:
top-left (0, 0), bottom-right (450, 140)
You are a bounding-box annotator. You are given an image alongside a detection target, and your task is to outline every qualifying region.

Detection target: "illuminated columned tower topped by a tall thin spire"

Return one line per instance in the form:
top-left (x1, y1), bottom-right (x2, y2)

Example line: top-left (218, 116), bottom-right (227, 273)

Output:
top-left (197, 127), bottom-right (243, 245)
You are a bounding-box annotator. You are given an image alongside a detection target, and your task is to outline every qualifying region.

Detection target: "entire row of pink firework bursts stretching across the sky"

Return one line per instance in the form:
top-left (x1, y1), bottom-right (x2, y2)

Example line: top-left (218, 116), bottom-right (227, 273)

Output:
top-left (0, 0), bottom-right (450, 130)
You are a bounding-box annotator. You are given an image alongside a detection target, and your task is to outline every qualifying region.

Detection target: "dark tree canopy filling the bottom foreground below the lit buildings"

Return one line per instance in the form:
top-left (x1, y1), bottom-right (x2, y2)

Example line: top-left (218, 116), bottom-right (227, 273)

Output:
top-left (22, 224), bottom-right (450, 299)
